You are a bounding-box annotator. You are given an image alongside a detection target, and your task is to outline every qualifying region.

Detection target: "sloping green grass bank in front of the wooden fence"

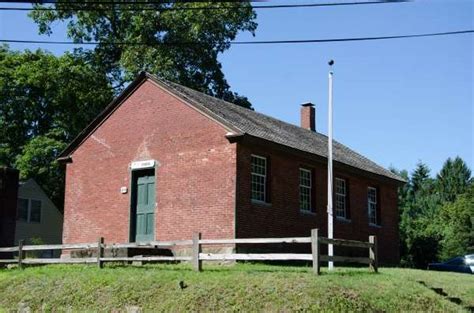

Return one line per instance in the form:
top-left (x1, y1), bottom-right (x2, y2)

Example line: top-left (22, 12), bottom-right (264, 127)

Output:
top-left (0, 264), bottom-right (474, 312)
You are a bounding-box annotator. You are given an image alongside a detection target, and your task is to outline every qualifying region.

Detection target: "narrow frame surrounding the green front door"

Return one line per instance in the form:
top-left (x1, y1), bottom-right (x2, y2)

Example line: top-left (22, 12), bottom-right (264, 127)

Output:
top-left (128, 166), bottom-right (158, 242)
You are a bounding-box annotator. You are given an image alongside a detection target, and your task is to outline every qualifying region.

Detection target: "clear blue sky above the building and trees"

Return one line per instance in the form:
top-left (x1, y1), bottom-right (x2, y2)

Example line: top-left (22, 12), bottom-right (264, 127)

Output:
top-left (0, 0), bottom-right (474, 174)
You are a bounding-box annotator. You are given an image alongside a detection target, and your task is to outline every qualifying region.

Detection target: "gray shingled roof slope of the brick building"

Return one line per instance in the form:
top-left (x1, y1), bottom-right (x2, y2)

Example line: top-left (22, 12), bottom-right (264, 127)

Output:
top-left (152, 76), bottom-right (404, 182)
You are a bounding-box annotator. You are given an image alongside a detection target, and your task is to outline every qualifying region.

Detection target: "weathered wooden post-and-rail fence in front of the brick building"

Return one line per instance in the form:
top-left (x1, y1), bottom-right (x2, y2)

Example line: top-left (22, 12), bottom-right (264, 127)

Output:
top-left (0, 229), bottom-right (378, 275)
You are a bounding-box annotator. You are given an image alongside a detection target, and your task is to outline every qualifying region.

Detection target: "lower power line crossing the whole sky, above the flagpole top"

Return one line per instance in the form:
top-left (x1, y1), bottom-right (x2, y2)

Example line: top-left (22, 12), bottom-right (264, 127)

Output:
top-left (0, 29), bottom-right (474, 46)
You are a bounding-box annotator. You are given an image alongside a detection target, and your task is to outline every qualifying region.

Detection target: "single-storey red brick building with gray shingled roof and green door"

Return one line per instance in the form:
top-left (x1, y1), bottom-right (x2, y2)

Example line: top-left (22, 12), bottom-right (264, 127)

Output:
top-left (59, 73), bottom-right (403, 263)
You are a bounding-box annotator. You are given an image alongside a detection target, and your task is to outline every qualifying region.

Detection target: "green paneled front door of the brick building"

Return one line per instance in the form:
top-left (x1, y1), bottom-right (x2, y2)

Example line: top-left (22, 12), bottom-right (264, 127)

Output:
top-left (135, 175), bottom-right (155, 241)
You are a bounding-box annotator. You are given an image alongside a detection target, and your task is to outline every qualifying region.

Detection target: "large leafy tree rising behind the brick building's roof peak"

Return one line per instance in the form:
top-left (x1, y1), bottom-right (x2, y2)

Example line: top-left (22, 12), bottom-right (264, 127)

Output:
top-left (30, 1), bottom-right (257, 107)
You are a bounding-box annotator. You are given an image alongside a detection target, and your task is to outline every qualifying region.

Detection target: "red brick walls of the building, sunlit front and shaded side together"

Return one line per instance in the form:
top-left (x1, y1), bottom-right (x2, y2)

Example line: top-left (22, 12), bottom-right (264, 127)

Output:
top-left (63, 77), bottom-right (399, 263)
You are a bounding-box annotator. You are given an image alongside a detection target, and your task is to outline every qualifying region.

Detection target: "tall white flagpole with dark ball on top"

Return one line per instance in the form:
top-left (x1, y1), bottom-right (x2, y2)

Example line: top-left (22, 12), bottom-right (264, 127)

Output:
top-left (328, 60), bottom-right (334, 270)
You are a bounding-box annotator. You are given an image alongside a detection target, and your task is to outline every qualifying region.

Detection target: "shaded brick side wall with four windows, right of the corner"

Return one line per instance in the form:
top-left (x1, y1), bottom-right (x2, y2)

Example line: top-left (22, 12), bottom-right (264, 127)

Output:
top-left (236, 139), bottom-right (399, 264)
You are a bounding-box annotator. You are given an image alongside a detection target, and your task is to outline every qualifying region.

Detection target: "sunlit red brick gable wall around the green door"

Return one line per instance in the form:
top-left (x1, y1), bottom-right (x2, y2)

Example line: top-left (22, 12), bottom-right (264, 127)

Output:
top-left (63, 81), bottom-right (236, 243)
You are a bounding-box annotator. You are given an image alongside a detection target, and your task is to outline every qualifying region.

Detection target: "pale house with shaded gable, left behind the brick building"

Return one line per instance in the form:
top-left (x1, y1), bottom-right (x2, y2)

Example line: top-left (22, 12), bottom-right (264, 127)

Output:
top-left (15, 179), bottom-right (63, 257)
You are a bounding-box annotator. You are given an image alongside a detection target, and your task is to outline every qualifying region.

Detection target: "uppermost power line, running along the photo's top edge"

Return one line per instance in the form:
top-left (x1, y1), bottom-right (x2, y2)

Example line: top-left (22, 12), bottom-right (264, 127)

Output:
top-left (0, 0), bottom-right (413, 11)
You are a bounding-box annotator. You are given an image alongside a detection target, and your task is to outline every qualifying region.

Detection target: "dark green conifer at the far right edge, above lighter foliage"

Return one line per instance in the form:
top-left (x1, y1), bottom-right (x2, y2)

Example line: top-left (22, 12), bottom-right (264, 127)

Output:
top-left (437, 157), bottom-right (472, 202)
